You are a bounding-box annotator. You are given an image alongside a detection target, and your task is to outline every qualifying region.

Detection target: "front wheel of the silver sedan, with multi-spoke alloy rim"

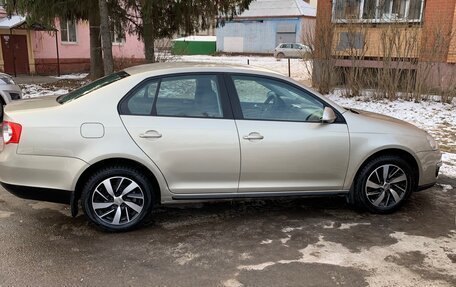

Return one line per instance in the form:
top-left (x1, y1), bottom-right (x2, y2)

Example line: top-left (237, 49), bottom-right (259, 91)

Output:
top-left (352, 156), bottom-right (416, 214)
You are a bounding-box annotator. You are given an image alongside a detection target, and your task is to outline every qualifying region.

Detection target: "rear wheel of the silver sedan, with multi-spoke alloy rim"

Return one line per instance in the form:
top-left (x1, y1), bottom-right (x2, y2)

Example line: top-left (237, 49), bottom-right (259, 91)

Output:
top-left (81, 165), bottom-right (154, 232)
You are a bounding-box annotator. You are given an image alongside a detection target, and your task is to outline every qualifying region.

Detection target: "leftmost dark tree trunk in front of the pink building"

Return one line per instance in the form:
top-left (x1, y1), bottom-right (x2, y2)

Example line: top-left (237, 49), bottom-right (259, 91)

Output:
top-left (89, 2), bottom-right (104, 80)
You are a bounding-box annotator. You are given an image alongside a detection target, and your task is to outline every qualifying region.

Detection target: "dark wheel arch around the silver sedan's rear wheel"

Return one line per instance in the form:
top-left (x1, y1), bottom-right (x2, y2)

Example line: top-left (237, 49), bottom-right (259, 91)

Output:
top-left (71, 157), bottom-right (161, 216)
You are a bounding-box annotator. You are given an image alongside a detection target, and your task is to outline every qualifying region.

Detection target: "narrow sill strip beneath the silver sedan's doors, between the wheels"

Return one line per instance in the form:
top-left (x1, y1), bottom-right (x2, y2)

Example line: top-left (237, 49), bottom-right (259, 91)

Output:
top-left (172, 190), bottom-right (349, 200)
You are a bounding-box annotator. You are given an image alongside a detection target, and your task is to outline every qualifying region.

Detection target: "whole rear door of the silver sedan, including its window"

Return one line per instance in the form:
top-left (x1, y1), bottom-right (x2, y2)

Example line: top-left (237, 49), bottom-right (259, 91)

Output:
top-left (121, 74), bottom-right (240, 194)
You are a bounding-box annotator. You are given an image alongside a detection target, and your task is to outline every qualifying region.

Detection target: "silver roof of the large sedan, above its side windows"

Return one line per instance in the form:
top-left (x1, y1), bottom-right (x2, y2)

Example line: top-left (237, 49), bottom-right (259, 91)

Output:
top-left (124, 62), bottom-right (281, 75)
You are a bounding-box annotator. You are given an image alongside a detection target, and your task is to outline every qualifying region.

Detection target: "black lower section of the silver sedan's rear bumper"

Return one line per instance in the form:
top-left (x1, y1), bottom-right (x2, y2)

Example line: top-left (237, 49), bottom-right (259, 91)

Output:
top-left (0, 182), bottom-right (72, 204)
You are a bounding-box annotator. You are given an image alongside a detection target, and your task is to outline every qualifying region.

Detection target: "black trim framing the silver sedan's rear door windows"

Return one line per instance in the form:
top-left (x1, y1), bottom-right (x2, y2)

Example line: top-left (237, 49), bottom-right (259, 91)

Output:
top-left (117, 72), bottom-right (234, 120)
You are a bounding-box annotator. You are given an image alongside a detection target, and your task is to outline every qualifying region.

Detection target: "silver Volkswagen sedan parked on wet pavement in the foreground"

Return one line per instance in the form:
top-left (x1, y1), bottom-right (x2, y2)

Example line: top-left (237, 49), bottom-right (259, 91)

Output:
top-left (0, 63), bottom-right (441, 231)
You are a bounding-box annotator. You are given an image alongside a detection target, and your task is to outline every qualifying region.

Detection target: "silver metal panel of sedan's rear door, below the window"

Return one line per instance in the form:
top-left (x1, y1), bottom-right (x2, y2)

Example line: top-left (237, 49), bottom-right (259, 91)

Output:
top-left (122, 116), bottom-right (240, 193)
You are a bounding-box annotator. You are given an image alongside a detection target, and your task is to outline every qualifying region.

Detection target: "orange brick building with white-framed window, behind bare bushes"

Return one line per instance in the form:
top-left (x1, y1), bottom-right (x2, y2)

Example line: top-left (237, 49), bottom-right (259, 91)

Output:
top-left (316, 0), bottom-right (456, 88)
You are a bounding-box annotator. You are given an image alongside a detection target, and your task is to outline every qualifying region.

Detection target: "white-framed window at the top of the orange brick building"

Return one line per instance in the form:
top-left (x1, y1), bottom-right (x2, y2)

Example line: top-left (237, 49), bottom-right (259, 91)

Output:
top-left (333, 0), bottom-right (424, 23)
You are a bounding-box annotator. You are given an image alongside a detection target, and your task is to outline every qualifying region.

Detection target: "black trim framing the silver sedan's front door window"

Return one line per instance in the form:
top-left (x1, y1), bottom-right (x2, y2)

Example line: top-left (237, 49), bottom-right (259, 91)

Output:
top-left (225, 73), bottom-right (346, 124)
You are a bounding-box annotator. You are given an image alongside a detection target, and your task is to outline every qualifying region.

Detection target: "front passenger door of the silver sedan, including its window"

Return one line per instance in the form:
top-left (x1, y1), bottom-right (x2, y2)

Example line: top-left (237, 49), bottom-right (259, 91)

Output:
top-left (230, 75), bottom-right (349, 192)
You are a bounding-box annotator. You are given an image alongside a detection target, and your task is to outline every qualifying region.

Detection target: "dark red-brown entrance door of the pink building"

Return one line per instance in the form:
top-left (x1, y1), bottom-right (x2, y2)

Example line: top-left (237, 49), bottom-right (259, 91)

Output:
top-left (1, 35), bottom-right (29, 75)
